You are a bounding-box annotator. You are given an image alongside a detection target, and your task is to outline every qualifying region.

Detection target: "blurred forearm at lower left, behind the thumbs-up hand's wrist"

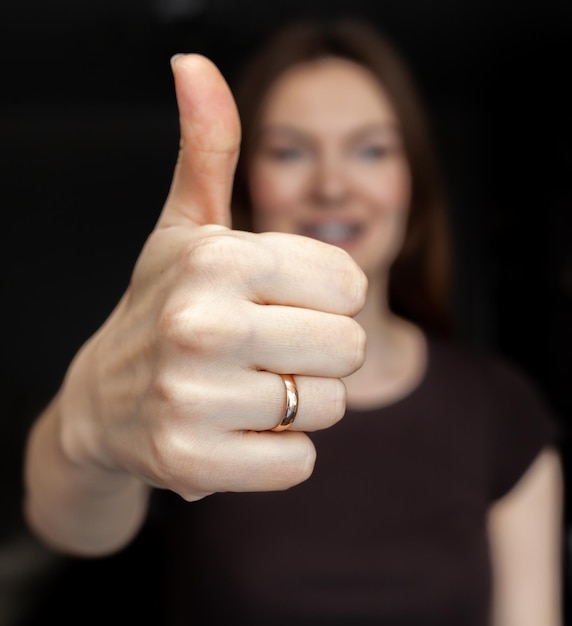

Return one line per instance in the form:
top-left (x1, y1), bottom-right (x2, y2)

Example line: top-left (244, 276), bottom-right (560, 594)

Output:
top-left (24, 396), bottom-right (149, 556)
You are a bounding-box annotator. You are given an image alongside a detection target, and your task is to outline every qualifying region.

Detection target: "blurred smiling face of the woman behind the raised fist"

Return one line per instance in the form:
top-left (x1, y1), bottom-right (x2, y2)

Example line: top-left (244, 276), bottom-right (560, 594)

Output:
top-left (250, 58), bottom-right (411, 277)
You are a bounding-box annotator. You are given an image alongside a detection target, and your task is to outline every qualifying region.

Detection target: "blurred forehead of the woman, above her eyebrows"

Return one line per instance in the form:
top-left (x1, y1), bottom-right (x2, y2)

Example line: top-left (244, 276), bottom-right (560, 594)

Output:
top-left (261, 57), bottom-right (397, 130)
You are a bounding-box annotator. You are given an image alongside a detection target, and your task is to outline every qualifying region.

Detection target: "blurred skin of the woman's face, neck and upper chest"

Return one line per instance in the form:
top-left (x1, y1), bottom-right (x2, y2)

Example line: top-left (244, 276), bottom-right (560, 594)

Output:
top-left (249, 58), bottom-right (426, 407)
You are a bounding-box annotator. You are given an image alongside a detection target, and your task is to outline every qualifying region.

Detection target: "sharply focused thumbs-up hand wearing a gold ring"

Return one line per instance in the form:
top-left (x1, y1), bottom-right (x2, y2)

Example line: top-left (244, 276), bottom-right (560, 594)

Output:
top-left (60, 55), bottom-right (366, 500)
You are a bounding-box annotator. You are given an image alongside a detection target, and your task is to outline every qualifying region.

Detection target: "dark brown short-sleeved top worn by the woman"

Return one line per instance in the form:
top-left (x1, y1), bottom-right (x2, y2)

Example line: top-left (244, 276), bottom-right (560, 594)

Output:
top-left (154, 340), bottom-right (555, 626)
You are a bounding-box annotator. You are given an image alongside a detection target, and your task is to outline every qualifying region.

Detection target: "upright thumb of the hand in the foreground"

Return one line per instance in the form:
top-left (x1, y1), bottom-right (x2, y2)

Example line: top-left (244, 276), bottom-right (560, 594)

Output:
top-left (158, 54), bottom-right (241, 227)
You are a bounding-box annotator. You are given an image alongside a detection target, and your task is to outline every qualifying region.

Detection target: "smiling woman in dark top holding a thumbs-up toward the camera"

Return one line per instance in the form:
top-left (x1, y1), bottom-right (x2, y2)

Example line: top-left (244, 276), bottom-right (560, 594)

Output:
top-left (23, 17), bottom-right (561, 626)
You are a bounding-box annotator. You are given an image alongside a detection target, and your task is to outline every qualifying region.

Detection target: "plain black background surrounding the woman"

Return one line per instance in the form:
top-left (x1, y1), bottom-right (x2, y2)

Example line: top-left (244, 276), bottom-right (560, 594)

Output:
top-left (0, 0), bottom-right (572, 626)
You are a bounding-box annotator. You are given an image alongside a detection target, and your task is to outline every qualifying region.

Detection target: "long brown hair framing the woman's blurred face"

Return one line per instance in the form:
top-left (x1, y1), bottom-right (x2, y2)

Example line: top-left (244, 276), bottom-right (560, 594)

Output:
top-left (233, 20), bottom-right (453, 334)
